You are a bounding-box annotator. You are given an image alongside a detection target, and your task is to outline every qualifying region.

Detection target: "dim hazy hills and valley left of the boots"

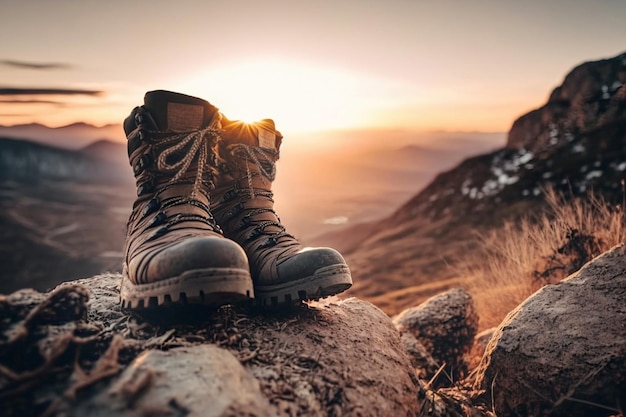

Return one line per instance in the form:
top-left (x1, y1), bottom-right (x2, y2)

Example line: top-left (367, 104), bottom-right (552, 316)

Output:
top-left (0, 138), bottom-right (135, 294)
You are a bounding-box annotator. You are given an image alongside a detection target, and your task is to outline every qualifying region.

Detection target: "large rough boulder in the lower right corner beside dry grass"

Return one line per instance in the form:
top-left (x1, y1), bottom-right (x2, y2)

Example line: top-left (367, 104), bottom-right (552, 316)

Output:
top-left (475, 246), bottom-right (626, 416)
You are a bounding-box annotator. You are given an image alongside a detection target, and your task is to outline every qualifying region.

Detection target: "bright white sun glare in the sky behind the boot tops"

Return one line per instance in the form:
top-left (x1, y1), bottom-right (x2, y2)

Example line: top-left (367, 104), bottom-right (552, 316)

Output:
top-left (169, 60), bottom-right (410, 131)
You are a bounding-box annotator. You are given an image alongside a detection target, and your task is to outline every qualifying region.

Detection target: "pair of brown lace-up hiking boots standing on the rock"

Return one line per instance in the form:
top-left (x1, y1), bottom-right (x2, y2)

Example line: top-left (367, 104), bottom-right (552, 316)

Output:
top-left (121, 90), bottom-right (352, 308)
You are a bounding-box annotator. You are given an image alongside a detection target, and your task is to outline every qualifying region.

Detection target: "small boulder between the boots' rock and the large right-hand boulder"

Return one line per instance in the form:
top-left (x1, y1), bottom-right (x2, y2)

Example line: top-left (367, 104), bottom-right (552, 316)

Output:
top-left (393, 288), bottom-right (478, 382)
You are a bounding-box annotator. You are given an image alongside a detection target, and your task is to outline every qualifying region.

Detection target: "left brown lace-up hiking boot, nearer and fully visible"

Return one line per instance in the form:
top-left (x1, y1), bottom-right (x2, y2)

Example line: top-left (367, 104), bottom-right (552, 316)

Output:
top-left (120, 91), bottom-right (253, 308)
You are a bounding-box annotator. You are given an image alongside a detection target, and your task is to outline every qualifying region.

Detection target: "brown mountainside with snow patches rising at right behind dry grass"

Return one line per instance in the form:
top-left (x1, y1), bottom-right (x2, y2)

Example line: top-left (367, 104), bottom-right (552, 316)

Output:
top-left (312, 50), bottom-right (626, 313)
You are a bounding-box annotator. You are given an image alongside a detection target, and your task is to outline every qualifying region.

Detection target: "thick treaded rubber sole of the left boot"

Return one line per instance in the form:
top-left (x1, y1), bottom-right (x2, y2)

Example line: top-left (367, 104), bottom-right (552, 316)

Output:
top-left (120, 268), bottom-right (254, 309)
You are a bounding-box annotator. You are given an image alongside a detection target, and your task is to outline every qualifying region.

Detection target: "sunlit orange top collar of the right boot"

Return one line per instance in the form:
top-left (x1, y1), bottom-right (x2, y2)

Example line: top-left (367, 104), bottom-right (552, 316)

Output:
top-left (222, 117), bottom-right (283, 151)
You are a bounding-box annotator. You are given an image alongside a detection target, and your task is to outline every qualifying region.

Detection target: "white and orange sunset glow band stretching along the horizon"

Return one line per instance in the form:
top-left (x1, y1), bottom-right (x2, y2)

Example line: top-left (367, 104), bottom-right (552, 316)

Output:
top-left (0, 58), bottom-right (541, 134)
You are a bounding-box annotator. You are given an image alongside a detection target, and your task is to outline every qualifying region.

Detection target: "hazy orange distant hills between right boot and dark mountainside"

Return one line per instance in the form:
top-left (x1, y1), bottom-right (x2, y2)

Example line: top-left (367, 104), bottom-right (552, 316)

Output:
top-left (274, 130), bottom-right (505, 239)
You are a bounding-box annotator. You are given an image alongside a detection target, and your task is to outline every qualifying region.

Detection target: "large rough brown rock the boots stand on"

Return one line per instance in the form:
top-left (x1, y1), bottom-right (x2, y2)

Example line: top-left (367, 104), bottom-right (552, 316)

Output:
top-left (0, 275), bottom-right (422, 416)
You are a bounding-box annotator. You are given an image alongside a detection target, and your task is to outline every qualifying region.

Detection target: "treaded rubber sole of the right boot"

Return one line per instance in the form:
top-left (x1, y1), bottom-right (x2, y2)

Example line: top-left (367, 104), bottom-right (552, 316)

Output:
top-left (254, 264), bottom-right (352, 306)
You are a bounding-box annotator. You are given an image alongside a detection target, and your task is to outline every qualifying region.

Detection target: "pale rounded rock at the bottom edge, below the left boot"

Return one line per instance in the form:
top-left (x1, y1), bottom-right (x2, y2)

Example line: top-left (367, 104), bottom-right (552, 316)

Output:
top-left (63, 345), bottom-right (281, 417)
